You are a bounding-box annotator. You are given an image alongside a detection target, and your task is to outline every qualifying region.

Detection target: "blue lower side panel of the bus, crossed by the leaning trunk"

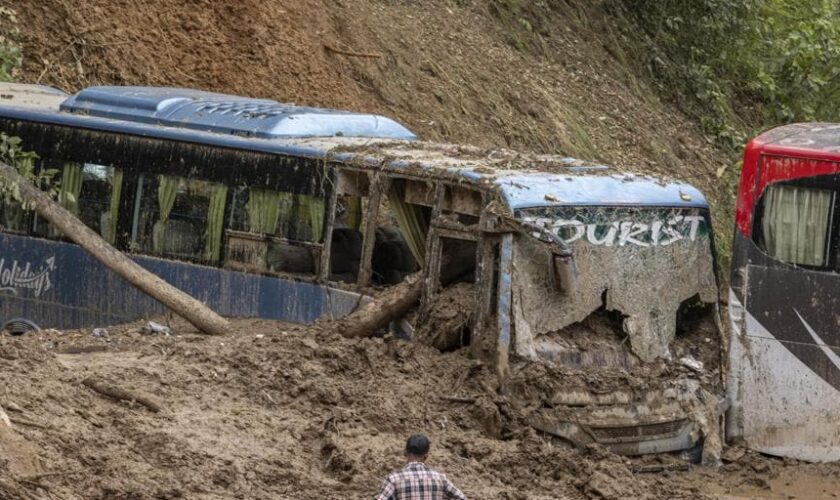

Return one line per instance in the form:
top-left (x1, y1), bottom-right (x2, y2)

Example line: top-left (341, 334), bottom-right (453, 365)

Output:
top-left (0, 234), bottom-right (360, 328)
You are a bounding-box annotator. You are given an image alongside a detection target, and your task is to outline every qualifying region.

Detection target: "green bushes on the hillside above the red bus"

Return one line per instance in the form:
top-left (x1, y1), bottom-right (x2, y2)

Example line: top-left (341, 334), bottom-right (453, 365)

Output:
top-left (607, 0), bottom-right (840, 150)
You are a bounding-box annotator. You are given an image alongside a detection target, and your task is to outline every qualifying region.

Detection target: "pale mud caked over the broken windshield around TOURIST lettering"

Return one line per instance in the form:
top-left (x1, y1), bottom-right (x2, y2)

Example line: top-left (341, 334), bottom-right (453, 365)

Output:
top-left (514, 205), bottom-right (718, 362)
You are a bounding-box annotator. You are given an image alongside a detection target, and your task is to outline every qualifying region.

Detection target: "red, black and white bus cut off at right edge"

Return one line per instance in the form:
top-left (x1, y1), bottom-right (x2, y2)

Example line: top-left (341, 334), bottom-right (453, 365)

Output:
top-left (727, 123), bottom-right (840, 461)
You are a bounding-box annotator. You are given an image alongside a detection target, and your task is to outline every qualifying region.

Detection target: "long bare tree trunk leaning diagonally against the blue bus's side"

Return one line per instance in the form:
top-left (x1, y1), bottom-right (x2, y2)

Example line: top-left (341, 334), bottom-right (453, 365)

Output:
top-left (0, 162), bottom-right (230, 334)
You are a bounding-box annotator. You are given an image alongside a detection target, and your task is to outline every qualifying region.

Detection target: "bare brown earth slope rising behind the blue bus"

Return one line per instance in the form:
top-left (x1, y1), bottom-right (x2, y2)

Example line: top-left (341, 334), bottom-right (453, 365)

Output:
top-left (0, 0), bottom-right (730, 211)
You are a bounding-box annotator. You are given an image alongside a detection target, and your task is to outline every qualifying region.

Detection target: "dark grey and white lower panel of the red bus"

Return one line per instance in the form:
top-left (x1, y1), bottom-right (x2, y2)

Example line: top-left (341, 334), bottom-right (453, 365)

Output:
top-left (728, 241), bottom-right (840, 461)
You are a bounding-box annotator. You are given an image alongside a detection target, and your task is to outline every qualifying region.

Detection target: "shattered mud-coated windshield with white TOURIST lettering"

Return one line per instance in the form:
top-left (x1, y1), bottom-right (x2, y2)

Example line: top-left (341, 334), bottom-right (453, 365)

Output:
top-left (514, 207), bottom-right (717, 361)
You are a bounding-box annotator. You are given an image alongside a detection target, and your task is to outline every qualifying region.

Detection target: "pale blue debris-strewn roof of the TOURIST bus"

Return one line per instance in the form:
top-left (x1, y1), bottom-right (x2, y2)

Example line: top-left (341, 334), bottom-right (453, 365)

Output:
top-left (0, 85), bottom-right (707, 210)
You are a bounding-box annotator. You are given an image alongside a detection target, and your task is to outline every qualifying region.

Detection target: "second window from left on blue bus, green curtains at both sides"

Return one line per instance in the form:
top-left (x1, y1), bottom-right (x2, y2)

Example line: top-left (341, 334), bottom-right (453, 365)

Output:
top-left (132, 175), bottom-right (227, 263)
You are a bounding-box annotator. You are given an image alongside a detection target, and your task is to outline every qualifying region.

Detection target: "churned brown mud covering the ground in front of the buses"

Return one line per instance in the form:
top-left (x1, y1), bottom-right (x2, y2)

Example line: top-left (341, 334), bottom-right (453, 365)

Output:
top-left (0, 320), bottom-right (840, 500)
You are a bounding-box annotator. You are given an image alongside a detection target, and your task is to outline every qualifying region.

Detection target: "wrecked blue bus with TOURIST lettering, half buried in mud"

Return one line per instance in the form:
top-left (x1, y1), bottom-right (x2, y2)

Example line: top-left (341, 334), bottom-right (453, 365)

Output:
top-left (0, 86), bottom-right (722, 454)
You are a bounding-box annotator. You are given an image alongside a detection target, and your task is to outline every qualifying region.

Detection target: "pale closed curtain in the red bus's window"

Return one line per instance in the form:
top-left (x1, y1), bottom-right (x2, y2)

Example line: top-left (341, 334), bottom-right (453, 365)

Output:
top-left (761, 185), bottom-right (834, 266)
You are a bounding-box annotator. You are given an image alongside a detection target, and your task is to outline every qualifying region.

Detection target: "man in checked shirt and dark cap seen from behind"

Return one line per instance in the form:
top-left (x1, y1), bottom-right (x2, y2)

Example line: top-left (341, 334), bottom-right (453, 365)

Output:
top-left (374, 434), bottom-right (467, 500)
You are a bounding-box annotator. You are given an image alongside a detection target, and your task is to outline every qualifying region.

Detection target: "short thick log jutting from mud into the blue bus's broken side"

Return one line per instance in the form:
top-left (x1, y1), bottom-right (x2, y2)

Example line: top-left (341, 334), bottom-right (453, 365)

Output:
top-left (341, 275), bottom-right (423, 338)
